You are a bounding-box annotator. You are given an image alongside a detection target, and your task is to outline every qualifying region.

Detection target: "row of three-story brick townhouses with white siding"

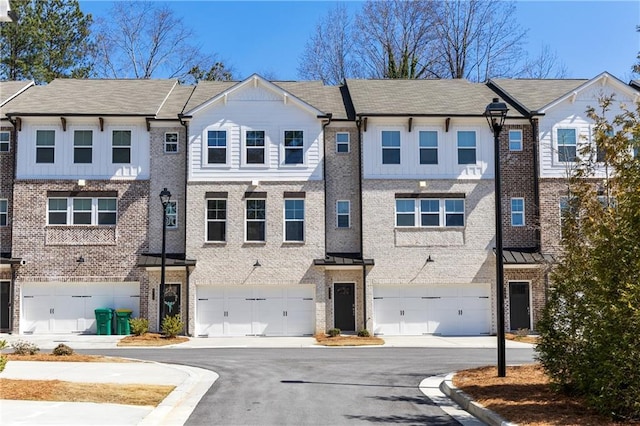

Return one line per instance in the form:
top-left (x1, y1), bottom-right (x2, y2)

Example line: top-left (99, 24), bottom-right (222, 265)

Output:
top-left (0, 73), bottom-right (639, 336)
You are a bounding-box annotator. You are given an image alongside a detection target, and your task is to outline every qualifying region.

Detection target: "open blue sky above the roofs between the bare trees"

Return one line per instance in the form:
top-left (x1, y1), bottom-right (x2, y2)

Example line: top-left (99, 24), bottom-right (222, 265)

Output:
top-left (80, 0), bottom-right (640, 82)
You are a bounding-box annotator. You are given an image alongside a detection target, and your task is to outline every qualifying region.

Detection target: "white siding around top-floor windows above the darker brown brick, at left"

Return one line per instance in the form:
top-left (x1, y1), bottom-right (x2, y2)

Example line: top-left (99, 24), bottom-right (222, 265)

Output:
top-left (16, 117), bottom-right (150, 180)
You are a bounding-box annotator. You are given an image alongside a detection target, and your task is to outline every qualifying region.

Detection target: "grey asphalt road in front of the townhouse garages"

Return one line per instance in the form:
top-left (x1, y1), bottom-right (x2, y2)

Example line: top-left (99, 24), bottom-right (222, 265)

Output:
top-left (83, 348), bottom-right (533, 425)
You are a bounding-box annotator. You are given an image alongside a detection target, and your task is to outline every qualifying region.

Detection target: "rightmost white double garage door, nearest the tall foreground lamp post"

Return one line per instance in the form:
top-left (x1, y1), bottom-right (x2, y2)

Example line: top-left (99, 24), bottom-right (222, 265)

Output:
top-left (373, 284), bottom-right (491, 335)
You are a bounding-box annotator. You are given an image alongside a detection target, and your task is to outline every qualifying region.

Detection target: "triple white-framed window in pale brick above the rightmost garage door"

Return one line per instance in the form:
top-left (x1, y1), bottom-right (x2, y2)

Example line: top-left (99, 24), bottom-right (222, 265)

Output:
top-left (396, 198), bottom-right (464, 228)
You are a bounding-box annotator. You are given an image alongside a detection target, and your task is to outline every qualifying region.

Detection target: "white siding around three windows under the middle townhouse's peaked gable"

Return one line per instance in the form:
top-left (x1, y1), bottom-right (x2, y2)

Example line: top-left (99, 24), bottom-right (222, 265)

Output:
top-left (188, 86), bottom-right (323, 182)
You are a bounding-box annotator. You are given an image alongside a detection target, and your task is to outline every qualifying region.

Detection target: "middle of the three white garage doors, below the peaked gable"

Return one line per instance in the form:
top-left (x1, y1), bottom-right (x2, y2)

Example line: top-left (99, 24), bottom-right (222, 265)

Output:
top-left (196, 285), bottom-right (315, 337)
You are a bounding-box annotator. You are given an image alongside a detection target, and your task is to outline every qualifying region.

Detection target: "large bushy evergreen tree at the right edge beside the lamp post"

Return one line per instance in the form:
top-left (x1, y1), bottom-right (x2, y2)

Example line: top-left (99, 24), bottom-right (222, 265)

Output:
top-left (537, 98), bottom-right (640, 420)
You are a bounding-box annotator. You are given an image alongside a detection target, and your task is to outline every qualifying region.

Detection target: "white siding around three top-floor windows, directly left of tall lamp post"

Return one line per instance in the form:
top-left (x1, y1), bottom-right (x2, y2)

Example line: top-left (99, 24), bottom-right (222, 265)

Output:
top-left (362, 118), bottom-right (494, 179)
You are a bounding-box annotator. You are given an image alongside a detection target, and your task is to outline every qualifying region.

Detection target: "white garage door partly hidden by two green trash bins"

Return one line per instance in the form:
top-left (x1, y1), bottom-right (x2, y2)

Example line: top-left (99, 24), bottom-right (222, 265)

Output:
top-left (20, 282), bottom-right (140, 333)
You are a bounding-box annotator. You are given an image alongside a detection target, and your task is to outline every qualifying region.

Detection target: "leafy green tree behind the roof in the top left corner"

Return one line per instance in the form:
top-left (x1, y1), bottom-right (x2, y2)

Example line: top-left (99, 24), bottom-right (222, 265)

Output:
top-left (0, 0), bottom-right (93, 83)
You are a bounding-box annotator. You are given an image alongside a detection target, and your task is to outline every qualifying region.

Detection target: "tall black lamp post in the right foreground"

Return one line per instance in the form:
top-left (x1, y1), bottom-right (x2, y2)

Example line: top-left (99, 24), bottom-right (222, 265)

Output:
top-left (484, 98), bottom-right (508, 377)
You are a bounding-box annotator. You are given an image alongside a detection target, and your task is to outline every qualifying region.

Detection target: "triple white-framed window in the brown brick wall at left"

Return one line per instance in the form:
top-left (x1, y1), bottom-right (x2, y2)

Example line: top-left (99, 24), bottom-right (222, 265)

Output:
top-left (47, 197), bottom-right (118, 226)
